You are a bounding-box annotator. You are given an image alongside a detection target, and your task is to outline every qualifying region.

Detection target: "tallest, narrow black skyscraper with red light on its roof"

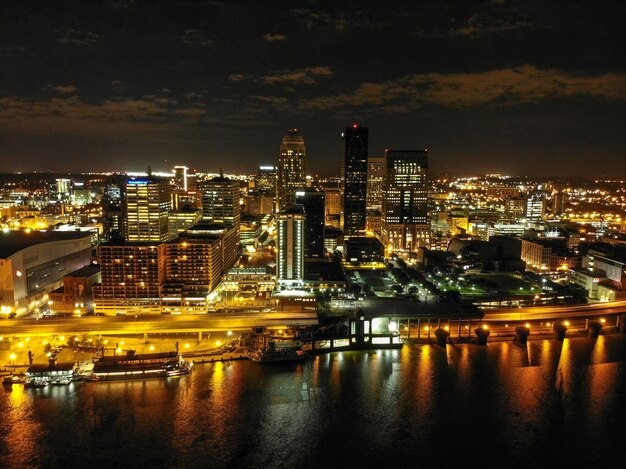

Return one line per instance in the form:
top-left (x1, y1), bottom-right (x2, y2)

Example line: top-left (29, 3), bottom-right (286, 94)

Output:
top-left (341, 124), bottom-right (368, 236)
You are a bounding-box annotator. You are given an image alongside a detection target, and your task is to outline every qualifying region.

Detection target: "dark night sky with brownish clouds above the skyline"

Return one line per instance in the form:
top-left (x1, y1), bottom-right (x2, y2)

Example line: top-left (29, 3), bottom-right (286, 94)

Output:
top-left (0, 0), bottom-right (626, 177)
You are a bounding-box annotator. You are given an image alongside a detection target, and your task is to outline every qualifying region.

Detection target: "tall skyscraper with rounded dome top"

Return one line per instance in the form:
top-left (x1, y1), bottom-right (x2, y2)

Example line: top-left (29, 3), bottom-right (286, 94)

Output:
top-left (276, 129), bottom-right (306, 208)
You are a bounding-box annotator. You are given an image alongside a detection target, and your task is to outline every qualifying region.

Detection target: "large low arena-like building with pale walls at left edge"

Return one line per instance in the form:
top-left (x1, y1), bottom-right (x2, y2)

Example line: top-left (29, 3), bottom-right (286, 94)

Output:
top-left (0, 231), bottom-right (93, 317)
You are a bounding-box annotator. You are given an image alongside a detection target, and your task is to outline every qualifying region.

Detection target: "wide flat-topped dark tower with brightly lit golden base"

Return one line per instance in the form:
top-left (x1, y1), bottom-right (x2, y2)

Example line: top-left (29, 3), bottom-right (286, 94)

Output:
top-left (382, 150), bottom-right (430, 252)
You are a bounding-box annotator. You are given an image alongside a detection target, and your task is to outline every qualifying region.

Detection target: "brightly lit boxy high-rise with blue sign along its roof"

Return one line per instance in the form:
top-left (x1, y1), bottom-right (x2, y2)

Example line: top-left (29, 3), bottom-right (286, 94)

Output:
top-left (125, 176), bottom-right (171, 242)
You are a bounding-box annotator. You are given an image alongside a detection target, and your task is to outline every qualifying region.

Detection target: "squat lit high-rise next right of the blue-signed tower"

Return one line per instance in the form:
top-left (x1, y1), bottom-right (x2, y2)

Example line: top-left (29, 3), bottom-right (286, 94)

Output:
top-left (202, 172), bottom-right (241, 231)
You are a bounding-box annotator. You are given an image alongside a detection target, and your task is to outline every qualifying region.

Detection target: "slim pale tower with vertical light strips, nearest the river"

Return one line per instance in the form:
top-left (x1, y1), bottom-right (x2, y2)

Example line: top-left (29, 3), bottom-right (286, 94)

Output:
top-left (276, 205), bottom-right (306, 287)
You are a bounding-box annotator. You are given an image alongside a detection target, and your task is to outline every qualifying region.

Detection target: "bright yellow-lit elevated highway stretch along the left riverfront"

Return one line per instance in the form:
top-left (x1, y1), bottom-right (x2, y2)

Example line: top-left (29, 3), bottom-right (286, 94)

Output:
top-left (0, 312), bottom-right (318, 337)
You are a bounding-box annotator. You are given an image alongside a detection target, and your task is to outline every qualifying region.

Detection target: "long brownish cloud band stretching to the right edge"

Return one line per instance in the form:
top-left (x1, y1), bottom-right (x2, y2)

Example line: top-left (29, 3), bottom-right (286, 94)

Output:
top-left (298, 65), bottom-right (626, 113)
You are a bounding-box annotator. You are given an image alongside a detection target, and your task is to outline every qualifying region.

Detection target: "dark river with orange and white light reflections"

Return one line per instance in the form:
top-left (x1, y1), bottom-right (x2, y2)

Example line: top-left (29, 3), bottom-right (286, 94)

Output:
top-left (0, 335), bottom-right (626, 468)
